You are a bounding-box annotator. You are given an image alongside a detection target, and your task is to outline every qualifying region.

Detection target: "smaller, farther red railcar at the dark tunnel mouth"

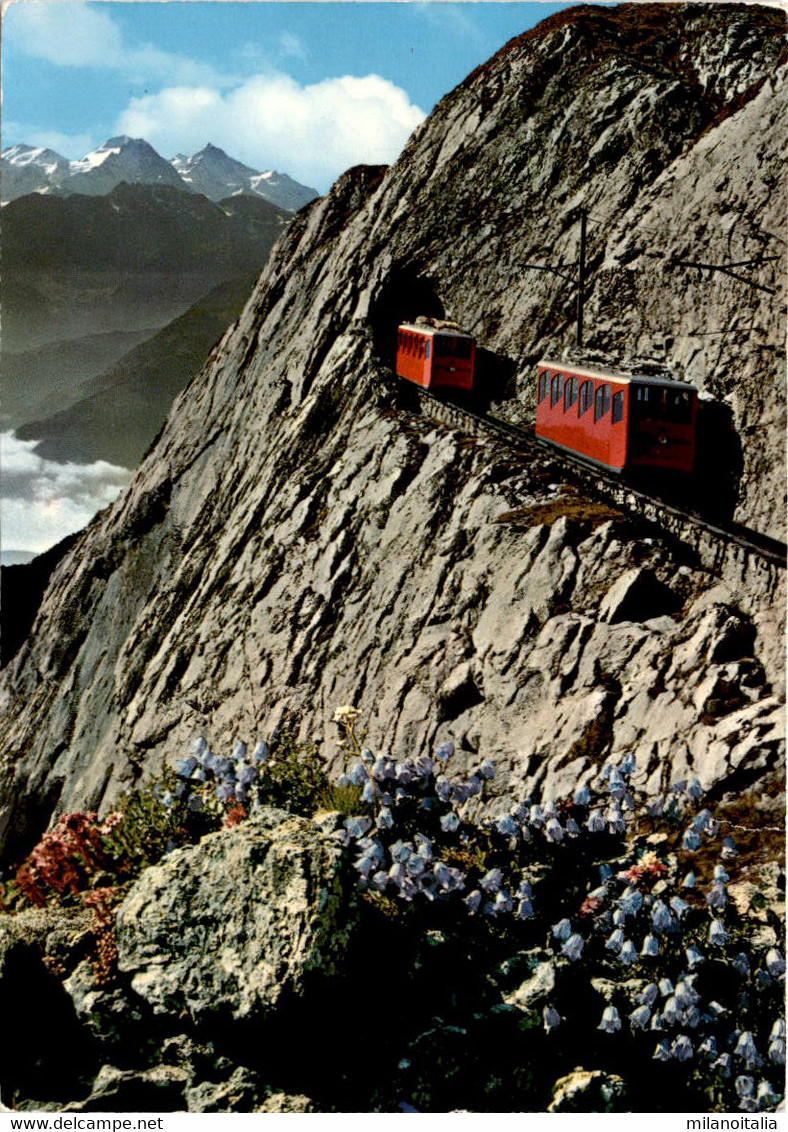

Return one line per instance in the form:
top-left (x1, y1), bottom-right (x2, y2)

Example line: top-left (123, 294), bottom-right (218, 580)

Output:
top-left (396, 323), bottom-right (476, 389)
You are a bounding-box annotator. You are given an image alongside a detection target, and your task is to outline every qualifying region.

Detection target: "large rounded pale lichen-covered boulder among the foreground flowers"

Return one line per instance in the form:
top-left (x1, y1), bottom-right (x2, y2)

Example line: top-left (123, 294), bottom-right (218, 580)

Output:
top-left (117, 809), bottom-right (353, 1021)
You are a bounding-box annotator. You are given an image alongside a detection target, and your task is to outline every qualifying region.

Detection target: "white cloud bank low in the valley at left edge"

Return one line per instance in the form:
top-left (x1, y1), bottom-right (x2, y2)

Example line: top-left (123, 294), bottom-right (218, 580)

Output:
top-left (0, 432), bottom-right (132, 554)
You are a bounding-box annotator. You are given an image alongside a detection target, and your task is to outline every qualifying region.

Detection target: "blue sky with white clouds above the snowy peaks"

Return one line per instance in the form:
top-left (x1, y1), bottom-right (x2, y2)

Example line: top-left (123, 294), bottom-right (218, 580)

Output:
top-left (2, 0), bottom-right (566, 191)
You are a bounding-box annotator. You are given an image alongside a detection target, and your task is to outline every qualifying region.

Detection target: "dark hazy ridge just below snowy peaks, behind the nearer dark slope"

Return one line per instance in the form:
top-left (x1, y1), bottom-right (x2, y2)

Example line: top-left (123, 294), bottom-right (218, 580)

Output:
top-left (2, 183), bottom-right (292, 353)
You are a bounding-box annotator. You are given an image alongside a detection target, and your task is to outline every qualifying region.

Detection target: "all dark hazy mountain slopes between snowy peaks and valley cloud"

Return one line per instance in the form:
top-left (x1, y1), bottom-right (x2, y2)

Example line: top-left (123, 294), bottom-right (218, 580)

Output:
top-left (0, 183), bottom-right (292, 466)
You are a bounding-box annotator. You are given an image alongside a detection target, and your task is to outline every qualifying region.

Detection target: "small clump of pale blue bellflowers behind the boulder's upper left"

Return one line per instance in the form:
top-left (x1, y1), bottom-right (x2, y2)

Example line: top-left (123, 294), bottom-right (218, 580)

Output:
top-left (167, 738), bottom-right (269, 813)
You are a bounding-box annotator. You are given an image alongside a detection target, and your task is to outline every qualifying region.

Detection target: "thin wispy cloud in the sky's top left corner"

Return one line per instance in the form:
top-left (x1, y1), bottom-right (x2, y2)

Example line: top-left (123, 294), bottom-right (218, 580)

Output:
top-left (7, 0), bottom-right (232, 86)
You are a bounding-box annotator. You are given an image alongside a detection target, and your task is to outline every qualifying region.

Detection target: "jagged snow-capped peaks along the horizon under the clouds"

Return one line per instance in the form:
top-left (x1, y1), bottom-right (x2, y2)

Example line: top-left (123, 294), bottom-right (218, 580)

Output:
top-left (0, 136), bottom-right (318, 212)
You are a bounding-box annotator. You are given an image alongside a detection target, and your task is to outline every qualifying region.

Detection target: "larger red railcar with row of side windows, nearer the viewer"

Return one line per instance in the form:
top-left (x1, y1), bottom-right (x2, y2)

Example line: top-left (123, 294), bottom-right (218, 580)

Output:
top-left (536, 360), bottom-right (697, 472)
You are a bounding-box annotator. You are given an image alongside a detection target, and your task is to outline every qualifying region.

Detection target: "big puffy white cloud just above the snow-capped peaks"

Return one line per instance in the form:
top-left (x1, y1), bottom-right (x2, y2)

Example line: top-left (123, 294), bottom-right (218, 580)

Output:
top-left (117, 74), bottom-right (425, 190)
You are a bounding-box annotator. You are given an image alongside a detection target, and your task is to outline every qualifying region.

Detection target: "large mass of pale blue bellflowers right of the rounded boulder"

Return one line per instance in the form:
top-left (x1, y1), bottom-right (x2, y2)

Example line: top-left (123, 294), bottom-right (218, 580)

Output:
top-left (332, 743), bottom-right (786, 1112)
